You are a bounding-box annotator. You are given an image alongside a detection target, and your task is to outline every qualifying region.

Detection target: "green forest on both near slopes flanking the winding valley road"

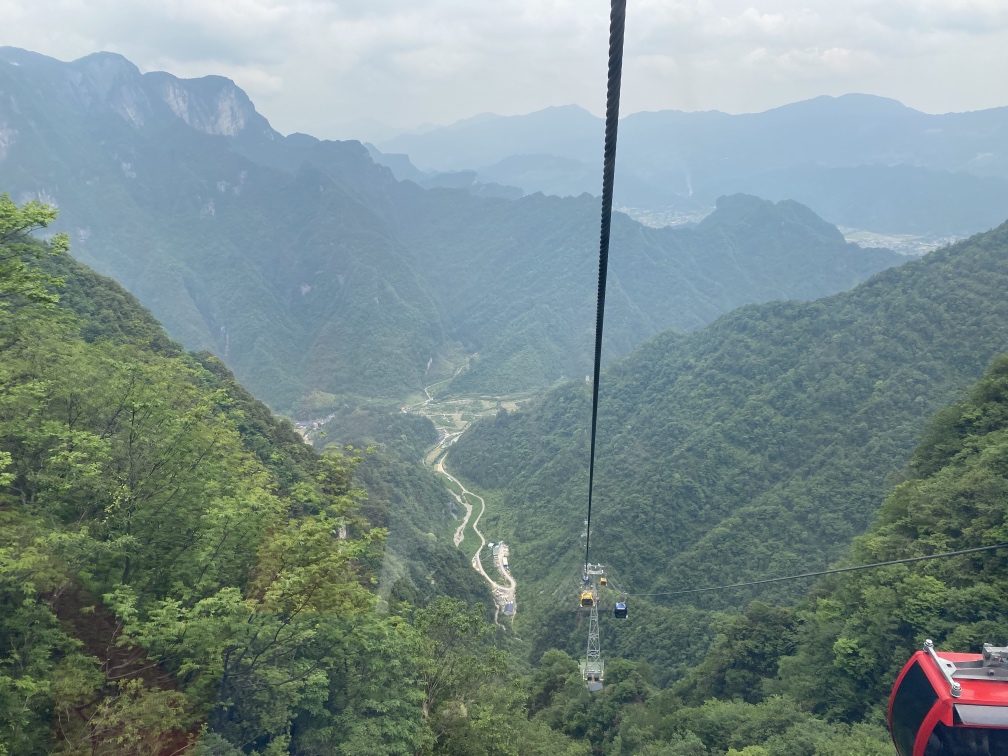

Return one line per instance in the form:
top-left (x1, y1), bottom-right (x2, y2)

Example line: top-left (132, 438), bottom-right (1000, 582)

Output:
top-left (0, 176), bottom-right (1008, 756)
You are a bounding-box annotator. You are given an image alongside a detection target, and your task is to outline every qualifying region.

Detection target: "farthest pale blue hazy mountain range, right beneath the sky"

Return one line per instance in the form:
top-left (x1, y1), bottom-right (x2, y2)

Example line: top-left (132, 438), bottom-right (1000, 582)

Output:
top-left (377, 95), bottom-right (1008, 236)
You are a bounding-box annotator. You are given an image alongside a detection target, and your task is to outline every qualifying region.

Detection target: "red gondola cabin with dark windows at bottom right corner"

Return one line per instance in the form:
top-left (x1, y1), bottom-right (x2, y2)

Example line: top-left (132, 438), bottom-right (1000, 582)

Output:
top-left (889, 640), bottom-right (1008, 756)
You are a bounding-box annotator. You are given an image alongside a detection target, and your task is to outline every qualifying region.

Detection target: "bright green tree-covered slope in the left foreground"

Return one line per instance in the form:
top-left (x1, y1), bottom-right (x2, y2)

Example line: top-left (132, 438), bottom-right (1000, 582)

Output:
top-left (0, 195), bottom-right (532, 756)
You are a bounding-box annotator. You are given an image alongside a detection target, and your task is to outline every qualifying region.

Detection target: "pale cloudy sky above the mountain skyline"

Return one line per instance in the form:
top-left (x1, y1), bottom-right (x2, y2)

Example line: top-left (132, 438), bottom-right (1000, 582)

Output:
top-left (0, 0), bottom-right (1008, 139)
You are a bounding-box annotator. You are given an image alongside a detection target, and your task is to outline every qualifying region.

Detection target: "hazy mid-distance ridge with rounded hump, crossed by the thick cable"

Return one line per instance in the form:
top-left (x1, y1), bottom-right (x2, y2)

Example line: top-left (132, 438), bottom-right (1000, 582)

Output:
top-left (383, 193), bottom-right (902, 391)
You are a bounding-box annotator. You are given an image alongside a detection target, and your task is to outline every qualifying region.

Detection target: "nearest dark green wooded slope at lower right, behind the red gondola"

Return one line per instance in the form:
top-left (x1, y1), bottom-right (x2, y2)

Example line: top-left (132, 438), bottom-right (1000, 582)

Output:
top-left (387, 355), bottom-right (1008, 756)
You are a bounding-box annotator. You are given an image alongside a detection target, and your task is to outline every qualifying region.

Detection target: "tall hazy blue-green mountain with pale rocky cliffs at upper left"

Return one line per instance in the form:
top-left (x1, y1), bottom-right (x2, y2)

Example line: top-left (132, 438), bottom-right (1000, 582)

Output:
top-left (0, 48), bottom-right (444, 408)
